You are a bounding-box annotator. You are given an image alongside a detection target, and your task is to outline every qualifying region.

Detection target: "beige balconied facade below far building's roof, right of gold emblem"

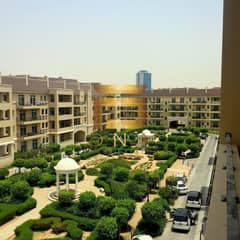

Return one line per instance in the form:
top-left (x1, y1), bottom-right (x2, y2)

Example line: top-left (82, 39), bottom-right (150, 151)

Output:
top-left (147, 95), bottom-right (220, 130)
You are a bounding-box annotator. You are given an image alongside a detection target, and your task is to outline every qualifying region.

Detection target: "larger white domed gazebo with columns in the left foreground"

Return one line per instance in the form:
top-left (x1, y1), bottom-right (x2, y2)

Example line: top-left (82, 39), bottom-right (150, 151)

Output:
top-left (54, 157), bottom-right (80, 197)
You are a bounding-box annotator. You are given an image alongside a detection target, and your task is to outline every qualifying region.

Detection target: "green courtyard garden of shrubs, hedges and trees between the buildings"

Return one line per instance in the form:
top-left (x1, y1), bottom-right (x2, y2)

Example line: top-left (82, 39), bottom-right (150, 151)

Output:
top-left (0, 124), bottom-right (206, 240)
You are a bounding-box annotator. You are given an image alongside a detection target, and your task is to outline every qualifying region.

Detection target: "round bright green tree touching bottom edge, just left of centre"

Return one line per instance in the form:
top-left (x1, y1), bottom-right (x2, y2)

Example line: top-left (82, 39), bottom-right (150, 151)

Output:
top-left (96, 217), bottom-right (118, 240)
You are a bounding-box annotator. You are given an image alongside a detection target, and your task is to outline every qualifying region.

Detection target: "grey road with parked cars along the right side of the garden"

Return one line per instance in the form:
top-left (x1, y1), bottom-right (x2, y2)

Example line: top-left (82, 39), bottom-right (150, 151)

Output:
top-left (154, 134), bottom-right (217, 240)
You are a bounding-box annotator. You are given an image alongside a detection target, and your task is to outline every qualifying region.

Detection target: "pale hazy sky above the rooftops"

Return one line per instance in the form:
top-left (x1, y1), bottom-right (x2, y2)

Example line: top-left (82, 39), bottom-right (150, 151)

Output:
top-left (0, 0), bottom-right (223, 88)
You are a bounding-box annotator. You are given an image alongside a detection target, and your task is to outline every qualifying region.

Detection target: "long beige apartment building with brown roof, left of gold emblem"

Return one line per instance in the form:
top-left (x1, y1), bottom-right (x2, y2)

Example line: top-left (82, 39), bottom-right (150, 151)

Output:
top-left (1, 75), bottom-right (93, 157)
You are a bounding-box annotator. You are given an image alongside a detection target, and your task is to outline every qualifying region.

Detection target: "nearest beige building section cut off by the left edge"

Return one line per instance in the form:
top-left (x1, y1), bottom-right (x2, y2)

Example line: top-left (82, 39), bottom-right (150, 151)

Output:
top-left (0, 81), bottom-right (16, 168)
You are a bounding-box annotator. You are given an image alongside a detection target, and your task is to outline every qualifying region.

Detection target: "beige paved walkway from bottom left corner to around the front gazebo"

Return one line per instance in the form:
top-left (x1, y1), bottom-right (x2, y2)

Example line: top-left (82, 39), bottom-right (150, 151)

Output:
top-left (0, 172), bottom-right (103, 240)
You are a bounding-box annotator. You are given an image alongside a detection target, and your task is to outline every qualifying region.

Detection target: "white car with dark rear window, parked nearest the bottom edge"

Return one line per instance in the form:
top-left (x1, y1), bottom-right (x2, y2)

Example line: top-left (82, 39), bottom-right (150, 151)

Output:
top-left (172, 208), bottom-right (198, 232)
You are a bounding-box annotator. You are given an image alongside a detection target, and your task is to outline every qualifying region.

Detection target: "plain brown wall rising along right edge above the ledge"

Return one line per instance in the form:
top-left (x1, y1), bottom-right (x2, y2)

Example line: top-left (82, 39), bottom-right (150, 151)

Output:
top-left (221, 0), bottom-right (240, 144)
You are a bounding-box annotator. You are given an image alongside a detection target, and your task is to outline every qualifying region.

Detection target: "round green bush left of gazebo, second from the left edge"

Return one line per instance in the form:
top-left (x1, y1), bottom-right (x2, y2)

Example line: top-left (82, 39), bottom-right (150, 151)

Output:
top-left (10, 181), bottom-right (30, 200)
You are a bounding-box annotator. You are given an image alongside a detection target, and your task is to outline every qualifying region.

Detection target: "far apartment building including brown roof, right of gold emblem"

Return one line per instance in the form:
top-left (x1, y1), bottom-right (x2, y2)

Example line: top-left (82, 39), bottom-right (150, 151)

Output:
top-left (145, 88), bottom-right (220, 130)
